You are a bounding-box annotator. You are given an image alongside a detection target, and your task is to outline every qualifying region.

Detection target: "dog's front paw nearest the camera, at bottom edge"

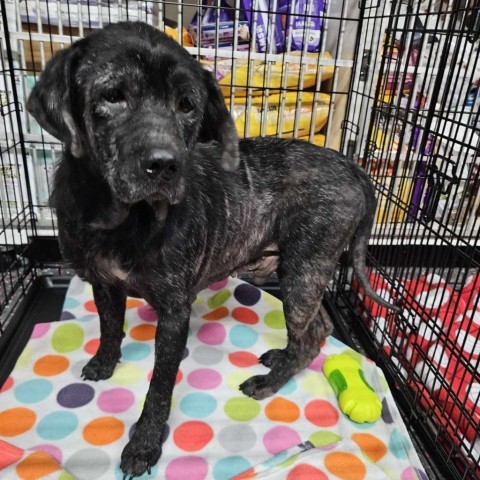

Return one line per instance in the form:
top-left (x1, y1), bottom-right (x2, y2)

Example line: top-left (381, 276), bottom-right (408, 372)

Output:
top-left (120, 434), bottom-right (162, 480)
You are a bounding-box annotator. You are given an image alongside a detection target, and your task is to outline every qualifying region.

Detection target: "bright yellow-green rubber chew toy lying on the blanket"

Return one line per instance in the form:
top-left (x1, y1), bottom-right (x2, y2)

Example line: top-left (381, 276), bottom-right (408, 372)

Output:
top-left (323, 353), bottom-right (382, 423)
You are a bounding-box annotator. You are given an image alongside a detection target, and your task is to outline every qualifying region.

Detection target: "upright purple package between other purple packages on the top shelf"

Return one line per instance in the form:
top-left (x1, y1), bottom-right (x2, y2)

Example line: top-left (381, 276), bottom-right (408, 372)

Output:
top-left (240, 0), bottom-right (285, 53)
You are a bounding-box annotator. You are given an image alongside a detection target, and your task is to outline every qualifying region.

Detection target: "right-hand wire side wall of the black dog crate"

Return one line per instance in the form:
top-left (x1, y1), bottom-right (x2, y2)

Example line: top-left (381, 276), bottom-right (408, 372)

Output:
top-left (334, 1), bottom-right (480, 478)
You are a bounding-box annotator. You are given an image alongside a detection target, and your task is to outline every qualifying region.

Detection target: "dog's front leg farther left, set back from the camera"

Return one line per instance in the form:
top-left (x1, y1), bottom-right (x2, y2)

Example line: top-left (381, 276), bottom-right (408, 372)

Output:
top-left (82, 283), bottom-right (127, 381)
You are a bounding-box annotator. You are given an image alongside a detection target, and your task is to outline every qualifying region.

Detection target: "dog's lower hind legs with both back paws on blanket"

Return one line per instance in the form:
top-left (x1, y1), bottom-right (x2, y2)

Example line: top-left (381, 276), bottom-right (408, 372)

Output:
top-left (240, 257), bottom-right (336, 400)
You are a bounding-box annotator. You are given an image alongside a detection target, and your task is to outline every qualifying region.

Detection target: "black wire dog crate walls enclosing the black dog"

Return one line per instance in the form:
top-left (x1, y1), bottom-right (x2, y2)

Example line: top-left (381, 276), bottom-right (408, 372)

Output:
top-left (0, 0), bottom-right (480, 479)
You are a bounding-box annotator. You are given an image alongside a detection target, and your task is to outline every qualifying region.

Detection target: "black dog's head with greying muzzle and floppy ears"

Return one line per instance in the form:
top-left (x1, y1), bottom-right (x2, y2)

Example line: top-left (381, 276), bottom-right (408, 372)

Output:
top-left (27, 22), bottom-right (238, 204)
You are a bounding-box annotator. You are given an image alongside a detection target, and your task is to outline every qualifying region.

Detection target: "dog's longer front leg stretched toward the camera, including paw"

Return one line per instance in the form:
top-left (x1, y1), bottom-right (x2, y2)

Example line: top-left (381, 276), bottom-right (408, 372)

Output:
top-left (121, 304), bottom-right (190, 478)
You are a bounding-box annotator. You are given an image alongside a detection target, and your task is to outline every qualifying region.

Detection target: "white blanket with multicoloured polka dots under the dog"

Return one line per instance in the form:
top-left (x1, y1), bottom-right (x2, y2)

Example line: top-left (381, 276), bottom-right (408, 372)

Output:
top-left (0, 278), bottom-right (427, 480)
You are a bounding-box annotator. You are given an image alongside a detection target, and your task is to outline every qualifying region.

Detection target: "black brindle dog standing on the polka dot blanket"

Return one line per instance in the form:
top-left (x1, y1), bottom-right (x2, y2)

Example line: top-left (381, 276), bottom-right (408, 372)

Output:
top-left (28, 23), bottom-right (396, 477)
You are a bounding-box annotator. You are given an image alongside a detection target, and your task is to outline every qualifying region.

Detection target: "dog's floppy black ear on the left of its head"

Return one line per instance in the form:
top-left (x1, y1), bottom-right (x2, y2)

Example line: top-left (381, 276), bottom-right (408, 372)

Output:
top-left (27, 47), bottom-right (83, 157)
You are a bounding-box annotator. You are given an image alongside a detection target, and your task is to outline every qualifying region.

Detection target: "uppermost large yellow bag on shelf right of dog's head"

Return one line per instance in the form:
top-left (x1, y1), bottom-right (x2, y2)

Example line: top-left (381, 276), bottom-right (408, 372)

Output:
top-left (219, 52), bottom-right (334, 97)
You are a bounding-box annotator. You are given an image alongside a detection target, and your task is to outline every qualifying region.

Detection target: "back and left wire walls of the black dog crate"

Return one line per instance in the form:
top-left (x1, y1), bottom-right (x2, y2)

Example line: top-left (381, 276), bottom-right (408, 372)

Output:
top-left (0, 0), bottom-right (359, 372)
